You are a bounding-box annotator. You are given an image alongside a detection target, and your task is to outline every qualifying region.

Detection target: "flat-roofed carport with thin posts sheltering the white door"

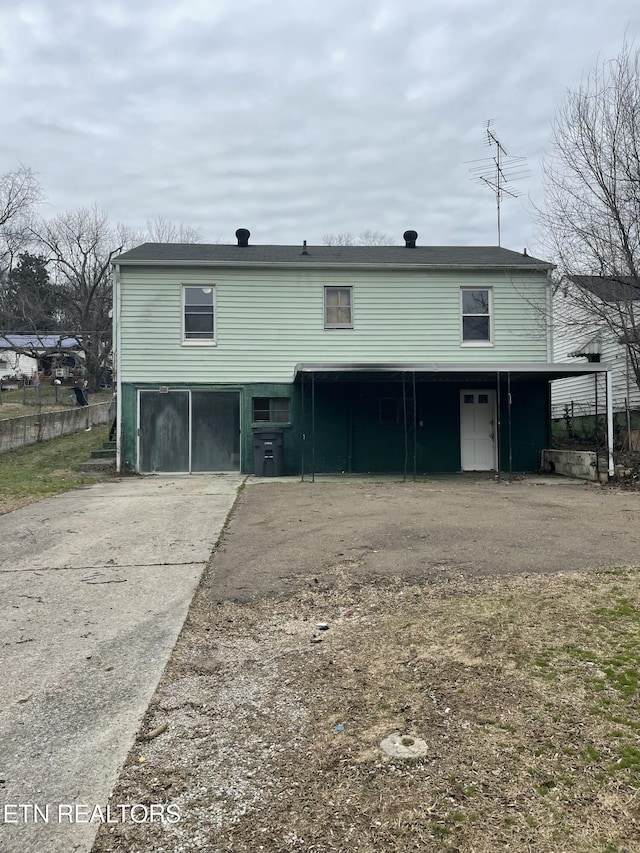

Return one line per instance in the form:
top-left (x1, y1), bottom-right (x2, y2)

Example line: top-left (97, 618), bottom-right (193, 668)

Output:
top-left (294, 363), bottom-right (614, 480)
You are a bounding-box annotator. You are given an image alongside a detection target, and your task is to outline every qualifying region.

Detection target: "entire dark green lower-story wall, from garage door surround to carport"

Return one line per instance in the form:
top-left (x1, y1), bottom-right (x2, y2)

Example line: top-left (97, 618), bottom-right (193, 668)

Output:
top-left (122, 377), bottom-right (549, 475)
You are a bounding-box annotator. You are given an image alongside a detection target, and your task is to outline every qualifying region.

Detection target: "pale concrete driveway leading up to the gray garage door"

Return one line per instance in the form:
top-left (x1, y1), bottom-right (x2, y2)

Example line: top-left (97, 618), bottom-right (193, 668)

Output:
top-left (0, 475), bottom-right (243, 853)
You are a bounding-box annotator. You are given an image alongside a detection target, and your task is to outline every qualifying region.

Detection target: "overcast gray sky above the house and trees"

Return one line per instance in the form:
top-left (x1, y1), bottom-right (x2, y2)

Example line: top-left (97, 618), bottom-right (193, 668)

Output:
top-left (0, 0), bottom-right (640, 253)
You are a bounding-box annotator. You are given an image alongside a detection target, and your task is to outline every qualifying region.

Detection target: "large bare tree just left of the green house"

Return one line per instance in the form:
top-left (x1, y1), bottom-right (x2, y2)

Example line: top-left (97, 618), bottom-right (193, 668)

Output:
top-left (34, 206), bottom-right (129, 390)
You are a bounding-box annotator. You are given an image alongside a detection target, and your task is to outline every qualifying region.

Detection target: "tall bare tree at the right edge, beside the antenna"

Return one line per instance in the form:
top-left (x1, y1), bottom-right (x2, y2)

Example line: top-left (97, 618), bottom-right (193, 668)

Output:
top-left (538, 43), bottom-right (640, 386)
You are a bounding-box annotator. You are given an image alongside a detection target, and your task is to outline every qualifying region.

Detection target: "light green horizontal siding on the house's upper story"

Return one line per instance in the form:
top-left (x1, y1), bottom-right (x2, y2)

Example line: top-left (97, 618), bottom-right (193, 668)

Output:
top-left (120, 266), bottom-right (547, 384)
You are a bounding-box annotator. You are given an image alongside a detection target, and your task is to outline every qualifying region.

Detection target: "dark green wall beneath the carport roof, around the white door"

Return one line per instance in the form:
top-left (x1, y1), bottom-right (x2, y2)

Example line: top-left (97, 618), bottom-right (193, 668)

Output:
top-left (304, 378), bottom-right (549, 473)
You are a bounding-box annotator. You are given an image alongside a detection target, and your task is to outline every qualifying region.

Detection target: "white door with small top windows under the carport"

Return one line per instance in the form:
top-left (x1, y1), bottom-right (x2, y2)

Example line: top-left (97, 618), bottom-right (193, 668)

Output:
top-left (460, 391), bottom-right (496, 471)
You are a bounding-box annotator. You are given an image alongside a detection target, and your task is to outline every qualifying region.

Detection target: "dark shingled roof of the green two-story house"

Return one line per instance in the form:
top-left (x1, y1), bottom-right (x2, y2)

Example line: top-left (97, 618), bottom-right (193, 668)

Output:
top-left (114, 243), bottom-right (553, 269)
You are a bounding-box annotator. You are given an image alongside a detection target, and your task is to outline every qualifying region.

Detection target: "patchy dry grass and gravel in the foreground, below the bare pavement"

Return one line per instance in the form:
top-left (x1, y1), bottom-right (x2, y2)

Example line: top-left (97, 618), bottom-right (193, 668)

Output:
top-left (94, 569), bottom-right (640, 853)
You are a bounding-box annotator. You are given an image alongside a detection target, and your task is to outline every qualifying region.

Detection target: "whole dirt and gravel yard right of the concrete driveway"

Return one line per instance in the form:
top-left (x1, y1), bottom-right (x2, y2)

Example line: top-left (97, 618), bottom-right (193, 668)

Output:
top-left (94, 477), bottom-right (640, 853)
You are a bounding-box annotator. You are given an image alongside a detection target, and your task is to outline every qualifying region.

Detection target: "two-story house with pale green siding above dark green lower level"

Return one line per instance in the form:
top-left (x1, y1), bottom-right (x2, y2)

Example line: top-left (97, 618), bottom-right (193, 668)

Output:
top-left (114, 229), bottom-right (606, 474)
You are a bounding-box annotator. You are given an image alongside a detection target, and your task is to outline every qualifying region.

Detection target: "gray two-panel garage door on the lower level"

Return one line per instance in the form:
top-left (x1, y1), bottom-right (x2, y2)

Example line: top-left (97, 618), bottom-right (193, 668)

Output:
top-left (139, 391), bottom-right (240, 473)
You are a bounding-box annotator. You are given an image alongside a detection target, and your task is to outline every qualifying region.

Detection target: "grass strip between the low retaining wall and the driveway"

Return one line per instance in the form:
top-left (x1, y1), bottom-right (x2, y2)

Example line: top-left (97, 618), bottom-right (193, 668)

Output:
top-left (0, 425), bottom-right (110, 514)
